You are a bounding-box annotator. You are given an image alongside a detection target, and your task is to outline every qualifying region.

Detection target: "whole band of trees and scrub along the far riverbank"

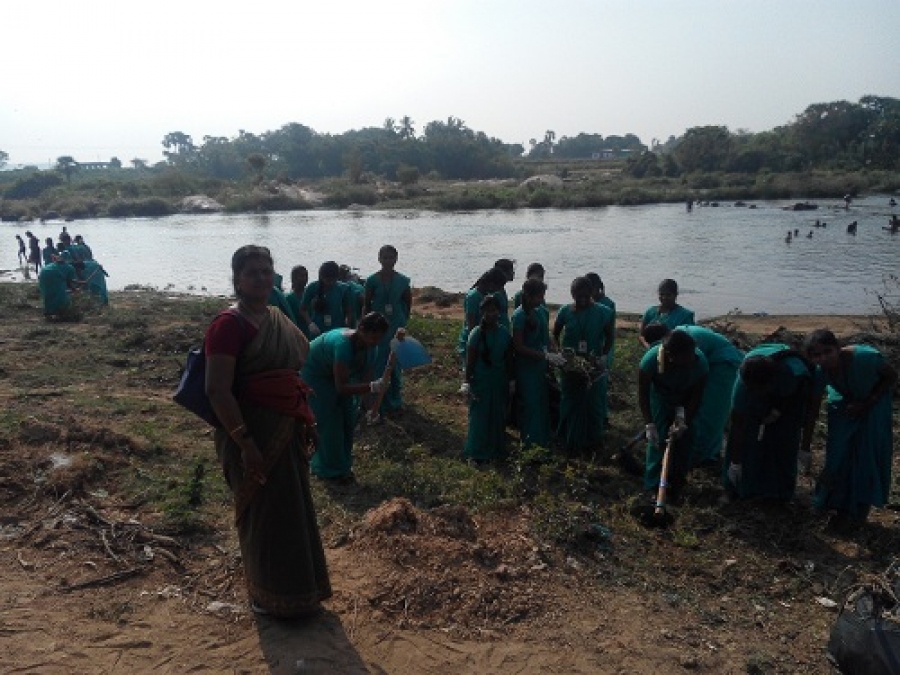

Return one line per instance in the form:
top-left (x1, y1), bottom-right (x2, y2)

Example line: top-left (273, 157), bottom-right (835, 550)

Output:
top-left (0, 96), bottom-right (900, 221)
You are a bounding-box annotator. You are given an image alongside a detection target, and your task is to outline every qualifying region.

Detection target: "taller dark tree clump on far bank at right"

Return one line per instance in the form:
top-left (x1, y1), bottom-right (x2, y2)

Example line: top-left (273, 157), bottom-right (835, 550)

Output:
top-left (625, 96), bottom-right (900, 178)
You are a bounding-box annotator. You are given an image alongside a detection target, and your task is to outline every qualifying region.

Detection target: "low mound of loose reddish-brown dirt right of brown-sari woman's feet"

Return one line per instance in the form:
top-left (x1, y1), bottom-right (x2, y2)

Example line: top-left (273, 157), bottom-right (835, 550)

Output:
top-left (351, 499), bottom-right (548, 637)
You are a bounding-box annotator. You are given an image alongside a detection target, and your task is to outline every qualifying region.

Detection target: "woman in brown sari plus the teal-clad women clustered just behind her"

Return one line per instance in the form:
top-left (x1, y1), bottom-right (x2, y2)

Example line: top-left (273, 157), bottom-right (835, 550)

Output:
top-left (204, 246), bottom-right (412, 617)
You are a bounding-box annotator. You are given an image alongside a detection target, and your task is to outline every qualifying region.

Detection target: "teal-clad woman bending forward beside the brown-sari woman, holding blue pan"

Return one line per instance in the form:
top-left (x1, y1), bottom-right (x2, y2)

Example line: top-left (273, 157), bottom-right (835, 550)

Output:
top-left (303, 312), bottom-right (388, 483)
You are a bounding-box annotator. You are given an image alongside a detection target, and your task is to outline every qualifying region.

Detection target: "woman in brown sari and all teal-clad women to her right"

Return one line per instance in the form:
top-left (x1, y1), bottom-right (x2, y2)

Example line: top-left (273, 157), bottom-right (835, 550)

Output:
top-left (205, 246), bottom-right (897, 617)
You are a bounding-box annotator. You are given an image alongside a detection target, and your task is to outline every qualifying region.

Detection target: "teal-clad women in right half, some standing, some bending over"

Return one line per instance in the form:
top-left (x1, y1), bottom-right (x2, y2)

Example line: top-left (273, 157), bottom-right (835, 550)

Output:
top-left (460, 261), bottom-right (897, 528)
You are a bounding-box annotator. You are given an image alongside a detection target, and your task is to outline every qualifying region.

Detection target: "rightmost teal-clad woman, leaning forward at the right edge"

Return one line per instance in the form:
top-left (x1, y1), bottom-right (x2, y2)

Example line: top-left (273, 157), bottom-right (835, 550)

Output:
top-left (805, 330), bottom-right (897, 527)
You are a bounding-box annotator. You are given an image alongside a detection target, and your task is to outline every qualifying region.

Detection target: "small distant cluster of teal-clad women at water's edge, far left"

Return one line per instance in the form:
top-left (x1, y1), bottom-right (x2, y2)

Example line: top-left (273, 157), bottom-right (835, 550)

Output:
top-left (35, 226), bottom-right (109, 318)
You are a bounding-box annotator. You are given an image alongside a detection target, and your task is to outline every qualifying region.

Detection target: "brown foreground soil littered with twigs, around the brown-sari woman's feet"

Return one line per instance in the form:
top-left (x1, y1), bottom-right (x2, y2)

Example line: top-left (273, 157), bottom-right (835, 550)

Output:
top-left (0, 284), bottom-right (900, 674)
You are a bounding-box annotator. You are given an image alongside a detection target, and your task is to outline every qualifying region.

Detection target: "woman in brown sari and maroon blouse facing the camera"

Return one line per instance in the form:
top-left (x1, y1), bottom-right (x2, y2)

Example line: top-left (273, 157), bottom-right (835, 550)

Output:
top-left (205, 246), bottom-right (331, 618)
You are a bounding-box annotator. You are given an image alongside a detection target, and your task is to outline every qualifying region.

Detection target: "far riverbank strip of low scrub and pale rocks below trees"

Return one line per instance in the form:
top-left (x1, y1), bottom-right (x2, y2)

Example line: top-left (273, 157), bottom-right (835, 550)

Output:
top-left (0, 161), bottom-right (900, 223)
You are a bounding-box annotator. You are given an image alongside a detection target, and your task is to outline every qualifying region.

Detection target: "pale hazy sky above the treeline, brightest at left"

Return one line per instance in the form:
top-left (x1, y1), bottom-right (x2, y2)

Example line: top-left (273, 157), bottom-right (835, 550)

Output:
top-left (0, 0), bottom-right (900, 165)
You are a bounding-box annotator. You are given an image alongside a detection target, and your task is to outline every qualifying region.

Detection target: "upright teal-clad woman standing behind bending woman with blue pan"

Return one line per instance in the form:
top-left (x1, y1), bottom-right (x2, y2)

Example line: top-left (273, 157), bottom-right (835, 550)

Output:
top-left (364, 245), bottom-right (412, 413)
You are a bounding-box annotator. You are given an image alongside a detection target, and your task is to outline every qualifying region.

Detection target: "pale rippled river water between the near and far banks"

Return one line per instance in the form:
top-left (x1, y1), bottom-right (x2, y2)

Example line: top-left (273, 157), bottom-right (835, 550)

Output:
top-left (0, 195), bottom-right (900, 317)
